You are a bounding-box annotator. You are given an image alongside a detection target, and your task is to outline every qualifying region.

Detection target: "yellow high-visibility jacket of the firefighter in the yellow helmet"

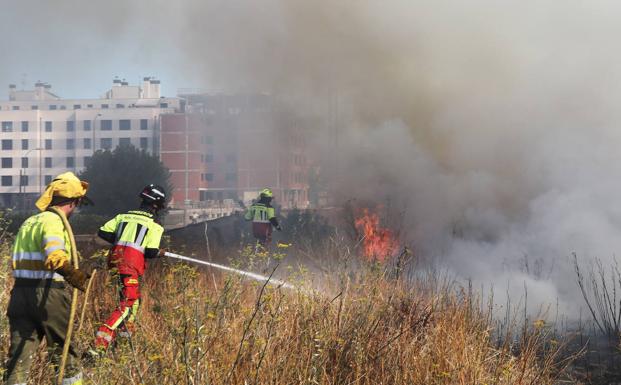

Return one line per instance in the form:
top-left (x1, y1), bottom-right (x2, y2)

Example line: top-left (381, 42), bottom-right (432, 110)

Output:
top-left (13, 211), bottom-right (71, 281)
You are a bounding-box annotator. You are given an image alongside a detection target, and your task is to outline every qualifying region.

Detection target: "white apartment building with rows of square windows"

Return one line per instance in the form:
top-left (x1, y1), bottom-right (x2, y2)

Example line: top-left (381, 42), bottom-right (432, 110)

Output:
top-left (0, 78), bottom-right (184, 208)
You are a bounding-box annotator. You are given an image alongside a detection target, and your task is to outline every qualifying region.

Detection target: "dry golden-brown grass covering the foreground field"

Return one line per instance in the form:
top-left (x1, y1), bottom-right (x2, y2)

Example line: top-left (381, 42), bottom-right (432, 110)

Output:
top-left (0, 246), bottom-right (563, 385)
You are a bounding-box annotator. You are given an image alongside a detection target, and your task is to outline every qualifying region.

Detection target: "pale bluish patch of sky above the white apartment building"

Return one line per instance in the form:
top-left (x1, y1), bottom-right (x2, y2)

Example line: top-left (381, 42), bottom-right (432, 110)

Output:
top-left (0, 0), bottom-right (194, 100)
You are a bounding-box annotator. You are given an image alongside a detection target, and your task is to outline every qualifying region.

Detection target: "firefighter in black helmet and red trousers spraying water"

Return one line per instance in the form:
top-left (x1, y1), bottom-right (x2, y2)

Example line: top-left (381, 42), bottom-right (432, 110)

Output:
top-left (88, 184), bottom-right (166, 358)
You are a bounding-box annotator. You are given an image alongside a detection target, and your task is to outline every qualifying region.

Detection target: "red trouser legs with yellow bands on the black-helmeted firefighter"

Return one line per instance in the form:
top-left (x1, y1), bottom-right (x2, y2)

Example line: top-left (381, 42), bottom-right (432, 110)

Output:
top-left (95, 275), bottom-right (140, 349)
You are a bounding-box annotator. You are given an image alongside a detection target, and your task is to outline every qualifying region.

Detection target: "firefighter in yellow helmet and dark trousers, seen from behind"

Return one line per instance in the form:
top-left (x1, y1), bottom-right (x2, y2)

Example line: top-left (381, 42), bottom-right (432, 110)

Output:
top-left (5, 172), bottom-right (90, 385)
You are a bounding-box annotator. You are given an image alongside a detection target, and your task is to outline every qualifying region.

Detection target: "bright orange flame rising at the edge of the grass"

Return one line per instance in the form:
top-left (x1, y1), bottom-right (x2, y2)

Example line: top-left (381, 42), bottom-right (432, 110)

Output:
top-left (354, 208), bottom-right (399, 262)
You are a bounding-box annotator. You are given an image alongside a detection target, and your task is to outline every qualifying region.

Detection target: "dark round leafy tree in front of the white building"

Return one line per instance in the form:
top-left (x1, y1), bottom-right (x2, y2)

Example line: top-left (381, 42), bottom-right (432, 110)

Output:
top-left (79, 145), bottom-right (172, 216)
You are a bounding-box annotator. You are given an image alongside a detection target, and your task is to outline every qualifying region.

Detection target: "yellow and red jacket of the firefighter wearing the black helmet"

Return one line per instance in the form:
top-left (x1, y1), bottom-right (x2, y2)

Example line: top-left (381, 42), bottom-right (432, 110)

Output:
top-left (99, 210), bottom-right (164, 276)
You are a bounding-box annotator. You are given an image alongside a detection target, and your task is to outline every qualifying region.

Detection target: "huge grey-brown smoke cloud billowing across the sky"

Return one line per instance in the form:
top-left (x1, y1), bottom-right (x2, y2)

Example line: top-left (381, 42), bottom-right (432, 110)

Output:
top-left (0, 0), bottom-right (621, 313)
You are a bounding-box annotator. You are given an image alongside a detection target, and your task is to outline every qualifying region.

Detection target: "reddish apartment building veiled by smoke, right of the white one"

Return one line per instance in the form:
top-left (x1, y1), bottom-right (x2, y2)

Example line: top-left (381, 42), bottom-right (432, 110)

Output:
top-left (161, 92), bottom-right (309, 208)
